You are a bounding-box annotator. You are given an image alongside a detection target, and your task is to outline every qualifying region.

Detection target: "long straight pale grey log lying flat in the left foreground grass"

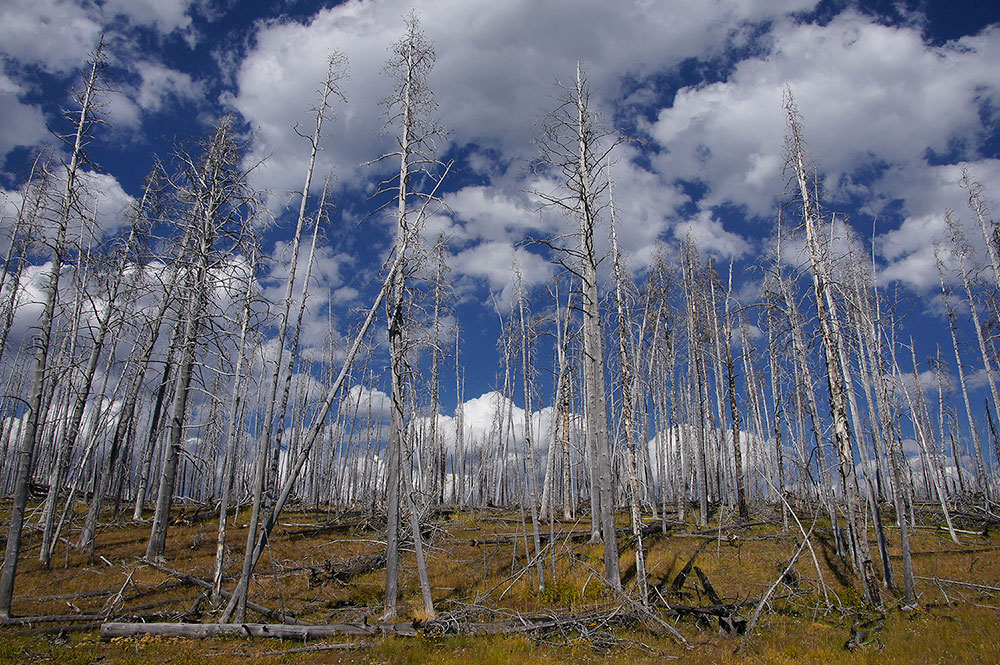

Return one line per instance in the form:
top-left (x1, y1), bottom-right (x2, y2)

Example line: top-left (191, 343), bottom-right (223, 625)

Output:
top-left (101, 622), bottom-right (417, 641)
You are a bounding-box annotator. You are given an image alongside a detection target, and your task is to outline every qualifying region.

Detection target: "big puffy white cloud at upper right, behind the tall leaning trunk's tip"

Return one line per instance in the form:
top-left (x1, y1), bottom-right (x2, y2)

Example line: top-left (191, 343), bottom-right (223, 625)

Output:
top-left (649, 11), bottom-right (1000, 286)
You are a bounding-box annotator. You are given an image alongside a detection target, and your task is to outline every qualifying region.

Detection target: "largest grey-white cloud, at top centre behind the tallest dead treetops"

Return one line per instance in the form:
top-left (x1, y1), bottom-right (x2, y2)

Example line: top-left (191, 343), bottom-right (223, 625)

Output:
top-left (232, 0), bottom-right (815, 205)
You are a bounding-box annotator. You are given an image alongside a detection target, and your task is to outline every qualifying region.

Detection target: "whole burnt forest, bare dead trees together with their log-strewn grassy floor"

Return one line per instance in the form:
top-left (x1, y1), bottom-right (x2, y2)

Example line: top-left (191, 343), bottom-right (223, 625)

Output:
top-left (0, 14), bottom-right (1000, 662)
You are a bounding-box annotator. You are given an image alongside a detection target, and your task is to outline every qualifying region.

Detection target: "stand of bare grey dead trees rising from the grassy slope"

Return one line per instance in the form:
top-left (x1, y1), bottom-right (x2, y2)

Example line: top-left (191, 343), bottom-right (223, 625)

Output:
top-left (0, 11), bottom-right (1000, 622)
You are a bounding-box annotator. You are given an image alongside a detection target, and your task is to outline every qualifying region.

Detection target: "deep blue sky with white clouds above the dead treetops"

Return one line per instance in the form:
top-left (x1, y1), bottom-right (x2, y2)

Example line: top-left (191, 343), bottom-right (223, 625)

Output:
top-left (0, 0), bottom-right (1000, 422)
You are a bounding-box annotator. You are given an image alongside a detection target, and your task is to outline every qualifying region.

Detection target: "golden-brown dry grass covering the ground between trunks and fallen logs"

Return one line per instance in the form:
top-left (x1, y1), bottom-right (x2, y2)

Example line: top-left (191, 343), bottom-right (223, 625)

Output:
top-left (0, 500), bottom-right (1000, 665)
